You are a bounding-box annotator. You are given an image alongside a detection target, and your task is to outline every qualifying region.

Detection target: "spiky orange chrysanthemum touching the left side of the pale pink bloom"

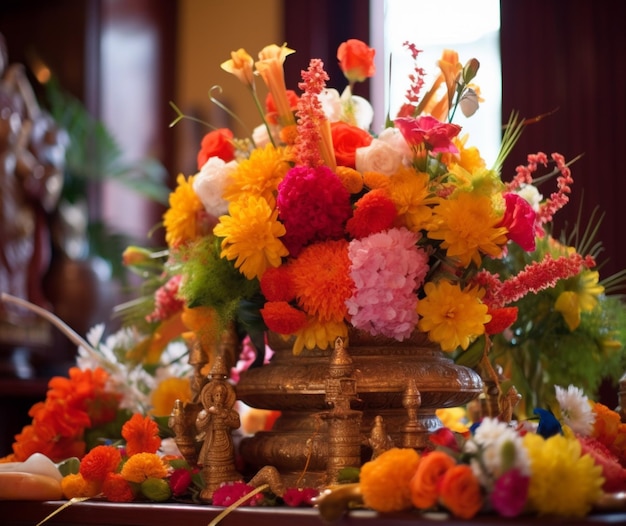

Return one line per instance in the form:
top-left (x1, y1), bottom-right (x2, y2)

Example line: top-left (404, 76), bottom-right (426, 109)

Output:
top-left (290, 240), bottom-right (354, 322)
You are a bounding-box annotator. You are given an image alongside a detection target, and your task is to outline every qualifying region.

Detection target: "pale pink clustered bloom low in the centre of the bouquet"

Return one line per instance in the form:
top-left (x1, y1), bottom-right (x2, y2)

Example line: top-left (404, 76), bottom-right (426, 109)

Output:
top-left (346, 228), bottom-right (428, 341)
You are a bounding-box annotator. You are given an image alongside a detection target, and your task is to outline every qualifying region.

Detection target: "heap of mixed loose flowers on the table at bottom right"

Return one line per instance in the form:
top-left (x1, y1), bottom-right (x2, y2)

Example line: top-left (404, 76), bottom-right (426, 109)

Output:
top-left (344, 385), bottom-right (626, 519)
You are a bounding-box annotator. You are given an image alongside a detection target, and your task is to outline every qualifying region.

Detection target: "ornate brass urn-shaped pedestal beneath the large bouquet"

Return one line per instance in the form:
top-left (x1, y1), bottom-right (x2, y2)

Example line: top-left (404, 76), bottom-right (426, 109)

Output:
top-left (237, 331), bottom-right (483, 485)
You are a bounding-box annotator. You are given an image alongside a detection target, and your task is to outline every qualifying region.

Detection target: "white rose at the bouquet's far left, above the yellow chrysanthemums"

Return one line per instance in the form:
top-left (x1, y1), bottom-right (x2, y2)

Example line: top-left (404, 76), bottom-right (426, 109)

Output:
top-left (193, 157), bottom-right (237, 217)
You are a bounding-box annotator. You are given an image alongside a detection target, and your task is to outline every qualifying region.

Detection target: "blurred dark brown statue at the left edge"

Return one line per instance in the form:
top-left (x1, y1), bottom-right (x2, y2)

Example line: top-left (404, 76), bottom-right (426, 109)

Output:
top-left (0, 35), bottom-right (67, 370)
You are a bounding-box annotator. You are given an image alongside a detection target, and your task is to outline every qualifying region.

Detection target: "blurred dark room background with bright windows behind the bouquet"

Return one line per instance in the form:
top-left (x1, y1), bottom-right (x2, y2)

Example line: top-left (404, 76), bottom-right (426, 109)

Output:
top-left (0, 0), bottom-right (626, 450)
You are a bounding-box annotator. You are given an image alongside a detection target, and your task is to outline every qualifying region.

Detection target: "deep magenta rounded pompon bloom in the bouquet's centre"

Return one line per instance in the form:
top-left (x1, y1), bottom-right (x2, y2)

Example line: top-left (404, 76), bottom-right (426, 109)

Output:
top-left (277, 166), bottom-right (352, 256)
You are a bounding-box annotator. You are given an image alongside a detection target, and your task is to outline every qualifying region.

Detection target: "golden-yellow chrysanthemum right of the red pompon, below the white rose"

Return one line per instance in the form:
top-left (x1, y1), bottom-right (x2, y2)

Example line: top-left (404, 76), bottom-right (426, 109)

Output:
top-left (387, 168), bottom-right (438, 232)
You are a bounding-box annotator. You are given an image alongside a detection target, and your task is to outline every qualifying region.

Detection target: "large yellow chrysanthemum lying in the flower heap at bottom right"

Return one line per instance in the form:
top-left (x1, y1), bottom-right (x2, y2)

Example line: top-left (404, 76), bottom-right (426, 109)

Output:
top-left (523, 433), bottom-right (604, 517)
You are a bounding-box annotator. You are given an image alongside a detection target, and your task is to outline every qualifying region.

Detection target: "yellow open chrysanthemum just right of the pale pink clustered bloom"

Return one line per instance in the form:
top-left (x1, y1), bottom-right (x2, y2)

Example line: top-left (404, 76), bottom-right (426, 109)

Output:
top-left (417, 281), bottom-right (491, 352)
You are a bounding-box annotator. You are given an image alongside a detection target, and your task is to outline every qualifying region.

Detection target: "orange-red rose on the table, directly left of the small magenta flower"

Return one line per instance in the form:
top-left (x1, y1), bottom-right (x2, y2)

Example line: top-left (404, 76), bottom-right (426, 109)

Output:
top-left (439, 464), bottom-right (483, 519)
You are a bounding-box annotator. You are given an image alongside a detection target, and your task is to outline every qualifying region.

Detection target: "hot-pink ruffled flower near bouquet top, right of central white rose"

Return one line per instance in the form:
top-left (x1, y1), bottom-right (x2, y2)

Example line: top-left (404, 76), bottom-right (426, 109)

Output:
top-left (394, 115), bottom-right (461, 153)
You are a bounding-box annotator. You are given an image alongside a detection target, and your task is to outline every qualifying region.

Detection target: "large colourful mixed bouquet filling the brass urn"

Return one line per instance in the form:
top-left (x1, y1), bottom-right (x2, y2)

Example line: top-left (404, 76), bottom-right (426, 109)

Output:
top-left (127, 35), bottom-right (616, 378)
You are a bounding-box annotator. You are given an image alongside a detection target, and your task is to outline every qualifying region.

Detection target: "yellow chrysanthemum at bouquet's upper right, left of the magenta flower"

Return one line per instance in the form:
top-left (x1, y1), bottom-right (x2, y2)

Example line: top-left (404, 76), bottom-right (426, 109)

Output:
top-left (428, 192), bottom-right (507, 267)
